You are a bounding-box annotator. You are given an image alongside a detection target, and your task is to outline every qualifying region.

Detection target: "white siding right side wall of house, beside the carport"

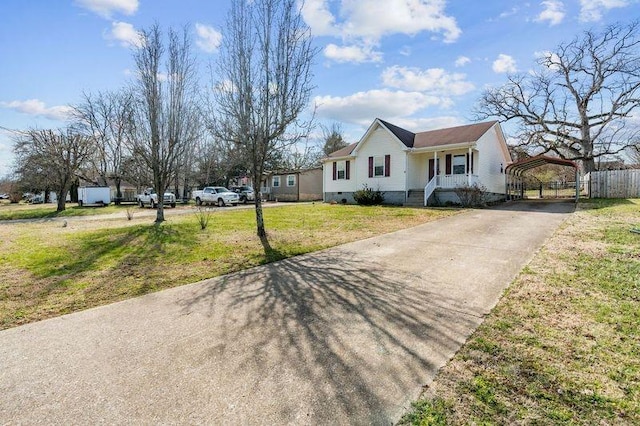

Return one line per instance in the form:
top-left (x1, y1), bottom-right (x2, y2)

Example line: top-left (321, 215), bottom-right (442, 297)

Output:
top-left (477, 126), bottom-right (511, 194)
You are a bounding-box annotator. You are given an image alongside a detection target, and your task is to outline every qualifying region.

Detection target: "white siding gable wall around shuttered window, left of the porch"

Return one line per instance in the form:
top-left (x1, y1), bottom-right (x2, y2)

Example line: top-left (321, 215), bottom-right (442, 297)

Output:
top-left (355, 127), bottom-right (406, 191)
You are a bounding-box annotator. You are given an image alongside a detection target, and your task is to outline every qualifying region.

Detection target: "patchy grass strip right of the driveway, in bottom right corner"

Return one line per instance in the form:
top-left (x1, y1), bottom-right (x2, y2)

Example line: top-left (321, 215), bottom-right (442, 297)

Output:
top-left (401, 200), bottom-right (640, 425)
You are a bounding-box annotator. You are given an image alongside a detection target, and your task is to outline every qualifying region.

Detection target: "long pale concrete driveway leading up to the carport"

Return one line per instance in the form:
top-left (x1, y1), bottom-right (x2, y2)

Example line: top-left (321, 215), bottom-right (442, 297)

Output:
top-left (0, 202), bottom-right (574, 425)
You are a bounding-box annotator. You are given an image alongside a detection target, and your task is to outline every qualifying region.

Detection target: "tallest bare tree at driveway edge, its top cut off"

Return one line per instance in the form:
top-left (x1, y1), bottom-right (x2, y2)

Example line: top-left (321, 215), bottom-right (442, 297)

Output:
top-left (215, 0), bottom-right (316, 238)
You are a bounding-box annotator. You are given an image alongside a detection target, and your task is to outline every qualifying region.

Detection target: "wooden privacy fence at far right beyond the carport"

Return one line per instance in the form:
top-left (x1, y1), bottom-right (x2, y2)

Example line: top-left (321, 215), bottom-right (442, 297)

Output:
top-left (585, 169), bottom-right (640, 198)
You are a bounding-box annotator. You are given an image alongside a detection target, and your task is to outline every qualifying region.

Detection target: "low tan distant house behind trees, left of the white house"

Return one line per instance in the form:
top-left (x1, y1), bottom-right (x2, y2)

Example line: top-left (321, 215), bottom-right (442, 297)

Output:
top-left (260, 167), bottom-right (322, 201)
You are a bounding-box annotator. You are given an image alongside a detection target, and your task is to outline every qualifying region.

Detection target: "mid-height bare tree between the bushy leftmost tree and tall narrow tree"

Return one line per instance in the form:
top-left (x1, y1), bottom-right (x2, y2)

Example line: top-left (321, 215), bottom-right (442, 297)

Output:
top-left (72, 90), bottom-right (133, 204)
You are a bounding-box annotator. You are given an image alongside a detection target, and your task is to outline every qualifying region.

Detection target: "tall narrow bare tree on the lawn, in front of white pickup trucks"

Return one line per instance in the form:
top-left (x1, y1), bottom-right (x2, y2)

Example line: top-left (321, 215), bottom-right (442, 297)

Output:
top-left (130, 25), bottom-right (200, 223)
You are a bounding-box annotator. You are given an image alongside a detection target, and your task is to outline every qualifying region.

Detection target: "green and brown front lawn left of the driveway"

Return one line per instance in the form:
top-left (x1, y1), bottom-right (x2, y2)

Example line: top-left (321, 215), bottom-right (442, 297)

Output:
top-left (0, 204), bottom-right (455, 328)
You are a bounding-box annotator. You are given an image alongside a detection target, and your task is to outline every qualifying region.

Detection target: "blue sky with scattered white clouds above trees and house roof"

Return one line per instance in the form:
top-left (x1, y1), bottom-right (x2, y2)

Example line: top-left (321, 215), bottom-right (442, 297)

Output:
top-left (0, 0), bottom-right (640, 176)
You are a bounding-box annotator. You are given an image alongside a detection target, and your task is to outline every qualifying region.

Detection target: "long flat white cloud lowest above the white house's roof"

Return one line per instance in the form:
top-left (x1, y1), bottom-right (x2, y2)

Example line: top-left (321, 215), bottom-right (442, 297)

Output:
top-left (314, 89), bottom-right (443, 126)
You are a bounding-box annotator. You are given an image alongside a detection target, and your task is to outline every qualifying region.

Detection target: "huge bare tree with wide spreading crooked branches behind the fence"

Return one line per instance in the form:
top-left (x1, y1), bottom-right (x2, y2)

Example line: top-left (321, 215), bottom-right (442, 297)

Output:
top-left (476, 22), bottom-right (640, 173)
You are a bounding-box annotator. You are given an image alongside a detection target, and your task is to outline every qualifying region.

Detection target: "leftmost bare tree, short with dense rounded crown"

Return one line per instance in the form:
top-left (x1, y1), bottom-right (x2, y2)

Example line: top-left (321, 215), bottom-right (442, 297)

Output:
top-left (14, 129), bottom-right (94, 212)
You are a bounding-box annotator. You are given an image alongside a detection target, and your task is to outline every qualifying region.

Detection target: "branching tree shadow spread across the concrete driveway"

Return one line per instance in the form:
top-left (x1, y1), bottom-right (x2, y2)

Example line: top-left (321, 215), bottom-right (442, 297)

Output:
top-left (179, 249), bottom-right (481, 424)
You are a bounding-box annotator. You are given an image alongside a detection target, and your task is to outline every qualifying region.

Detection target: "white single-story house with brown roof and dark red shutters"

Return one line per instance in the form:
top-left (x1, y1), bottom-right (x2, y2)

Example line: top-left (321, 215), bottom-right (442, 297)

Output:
top-left (322, 118), bottom-right (511, 206)
